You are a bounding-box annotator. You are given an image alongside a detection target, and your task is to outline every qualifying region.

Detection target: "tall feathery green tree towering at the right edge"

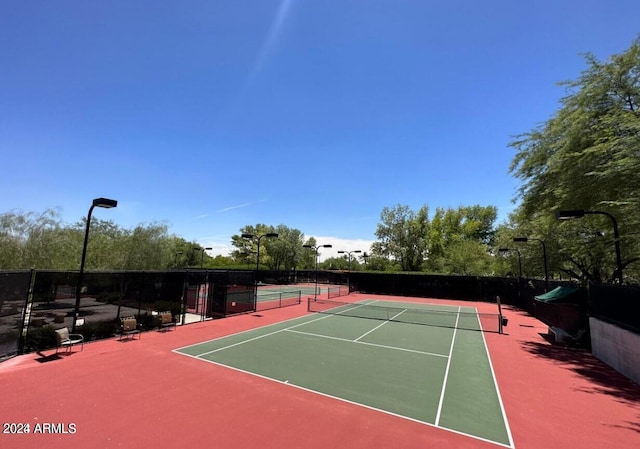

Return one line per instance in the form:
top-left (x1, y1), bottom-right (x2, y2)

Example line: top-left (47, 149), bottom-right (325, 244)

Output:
top-left (510, 37), bottom-right (640, 280)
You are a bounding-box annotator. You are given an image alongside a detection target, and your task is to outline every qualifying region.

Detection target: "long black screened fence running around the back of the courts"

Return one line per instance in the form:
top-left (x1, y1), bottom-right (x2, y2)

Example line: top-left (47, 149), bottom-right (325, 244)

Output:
top-left (0, 270), bottom-right (640, 360)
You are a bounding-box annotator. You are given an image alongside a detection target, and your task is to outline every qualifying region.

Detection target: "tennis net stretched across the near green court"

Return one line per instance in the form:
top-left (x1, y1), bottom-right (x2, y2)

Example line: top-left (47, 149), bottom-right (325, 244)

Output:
top-left (307, 298), bottom-right (502, 333)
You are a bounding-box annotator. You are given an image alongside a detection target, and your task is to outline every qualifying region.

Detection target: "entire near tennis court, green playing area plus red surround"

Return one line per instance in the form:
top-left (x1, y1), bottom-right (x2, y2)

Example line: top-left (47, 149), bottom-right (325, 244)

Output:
top-left (0, 293), bottom-right (640, 449)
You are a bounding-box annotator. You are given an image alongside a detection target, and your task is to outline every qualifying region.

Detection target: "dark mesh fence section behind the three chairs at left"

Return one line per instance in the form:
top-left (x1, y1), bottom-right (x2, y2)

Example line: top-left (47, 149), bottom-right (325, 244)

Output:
top-left (25, 271), bottom-right (185, 352)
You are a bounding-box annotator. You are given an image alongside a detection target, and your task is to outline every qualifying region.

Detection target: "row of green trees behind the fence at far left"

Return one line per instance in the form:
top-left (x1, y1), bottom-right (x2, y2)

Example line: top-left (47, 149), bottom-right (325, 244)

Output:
top-left (0, 210), bottom-right (200, 270)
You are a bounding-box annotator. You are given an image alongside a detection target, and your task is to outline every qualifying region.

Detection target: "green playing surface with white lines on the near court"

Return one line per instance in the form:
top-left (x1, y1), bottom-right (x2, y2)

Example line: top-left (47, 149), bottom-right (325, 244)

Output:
top-left (176, 300), bottom-right (513, 447)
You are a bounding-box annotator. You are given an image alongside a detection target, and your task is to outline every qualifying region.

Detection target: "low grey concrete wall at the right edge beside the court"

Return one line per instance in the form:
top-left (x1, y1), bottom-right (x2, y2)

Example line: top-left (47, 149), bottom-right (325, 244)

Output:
top-left (589, 317), bottom-right (640, 384)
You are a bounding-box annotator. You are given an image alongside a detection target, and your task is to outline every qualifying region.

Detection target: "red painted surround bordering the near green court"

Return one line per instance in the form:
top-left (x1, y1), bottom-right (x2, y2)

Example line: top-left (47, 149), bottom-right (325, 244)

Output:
top-left (0, 295), bottom-right (640, 449)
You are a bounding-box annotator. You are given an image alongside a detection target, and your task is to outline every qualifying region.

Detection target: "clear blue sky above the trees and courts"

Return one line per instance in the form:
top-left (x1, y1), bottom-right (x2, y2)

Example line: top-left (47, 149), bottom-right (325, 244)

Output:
top-left (0, 0), bottom-right (640, 255)
